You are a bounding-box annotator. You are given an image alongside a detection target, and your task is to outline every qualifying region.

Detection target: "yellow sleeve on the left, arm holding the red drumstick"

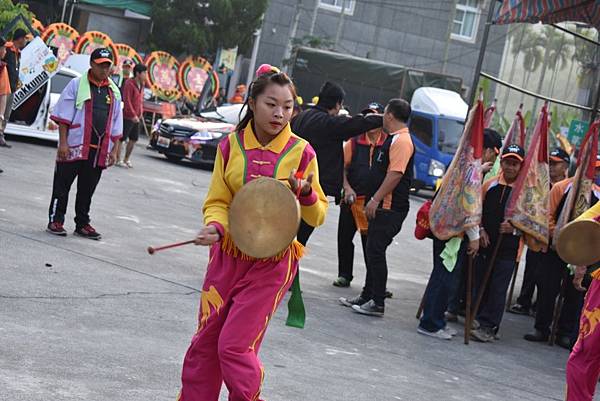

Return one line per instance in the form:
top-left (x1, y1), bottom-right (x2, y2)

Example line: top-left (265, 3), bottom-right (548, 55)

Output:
top-left (202, 147), bottom-right (233, 235)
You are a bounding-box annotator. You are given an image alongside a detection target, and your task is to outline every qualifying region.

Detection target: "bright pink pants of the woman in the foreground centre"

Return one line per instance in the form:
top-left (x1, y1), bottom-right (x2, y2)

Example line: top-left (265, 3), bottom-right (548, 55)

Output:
top-left (179, 244), bottom-right (298, 401)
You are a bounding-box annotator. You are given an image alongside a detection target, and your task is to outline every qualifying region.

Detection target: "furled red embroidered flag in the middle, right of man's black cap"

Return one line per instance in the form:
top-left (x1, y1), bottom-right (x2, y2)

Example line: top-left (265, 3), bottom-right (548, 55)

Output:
top-left (504, 104), bottom-right (550, 247)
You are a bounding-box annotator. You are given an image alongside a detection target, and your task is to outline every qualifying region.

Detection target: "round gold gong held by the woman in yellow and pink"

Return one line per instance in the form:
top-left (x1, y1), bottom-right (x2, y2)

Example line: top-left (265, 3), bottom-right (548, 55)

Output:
top-left (229, 177), bottom-right (300, 259)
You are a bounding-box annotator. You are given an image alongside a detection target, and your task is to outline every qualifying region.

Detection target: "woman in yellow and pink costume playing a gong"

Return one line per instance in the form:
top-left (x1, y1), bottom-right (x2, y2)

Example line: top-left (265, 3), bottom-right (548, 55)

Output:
top-left (179, 65), bottom-right (327, 401)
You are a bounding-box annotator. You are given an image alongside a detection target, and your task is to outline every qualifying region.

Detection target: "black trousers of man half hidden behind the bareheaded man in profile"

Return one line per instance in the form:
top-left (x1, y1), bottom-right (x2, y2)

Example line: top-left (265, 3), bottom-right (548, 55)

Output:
top-left (338, 203), bottom-right (367, 281)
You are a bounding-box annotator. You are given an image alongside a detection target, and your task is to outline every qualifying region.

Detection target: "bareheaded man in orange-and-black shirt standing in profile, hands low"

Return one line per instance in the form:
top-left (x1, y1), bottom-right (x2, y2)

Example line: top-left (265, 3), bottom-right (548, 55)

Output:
top-left (346, 99), bottom-right (415, 317)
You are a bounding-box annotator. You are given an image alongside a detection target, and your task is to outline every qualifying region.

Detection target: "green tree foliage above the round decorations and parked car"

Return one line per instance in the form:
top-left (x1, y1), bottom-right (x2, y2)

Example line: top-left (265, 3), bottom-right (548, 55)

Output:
top-left (150, 0), bottom-right (268, 56)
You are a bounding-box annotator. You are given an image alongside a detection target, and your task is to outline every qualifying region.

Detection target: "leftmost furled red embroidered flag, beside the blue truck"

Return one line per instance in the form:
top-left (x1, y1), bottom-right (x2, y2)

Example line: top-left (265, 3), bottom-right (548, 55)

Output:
top-left (429, 100), bottom-right (484, 240)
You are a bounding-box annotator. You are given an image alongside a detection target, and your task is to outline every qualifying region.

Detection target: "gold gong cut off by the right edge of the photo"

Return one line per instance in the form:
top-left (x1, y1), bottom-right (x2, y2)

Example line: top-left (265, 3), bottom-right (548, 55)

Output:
top-left (556, 220), bottom-right (600, 266)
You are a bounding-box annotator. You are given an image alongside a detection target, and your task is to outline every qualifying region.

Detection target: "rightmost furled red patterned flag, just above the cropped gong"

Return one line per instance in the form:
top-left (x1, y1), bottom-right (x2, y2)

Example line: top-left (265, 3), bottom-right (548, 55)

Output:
top-left (553, 121), bottom-right (600, 241)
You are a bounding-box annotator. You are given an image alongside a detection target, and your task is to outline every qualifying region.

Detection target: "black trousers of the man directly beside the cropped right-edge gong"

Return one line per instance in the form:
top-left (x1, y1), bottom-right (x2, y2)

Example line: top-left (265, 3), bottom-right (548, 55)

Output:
top-left (535, 250), bottom-right (584, 337)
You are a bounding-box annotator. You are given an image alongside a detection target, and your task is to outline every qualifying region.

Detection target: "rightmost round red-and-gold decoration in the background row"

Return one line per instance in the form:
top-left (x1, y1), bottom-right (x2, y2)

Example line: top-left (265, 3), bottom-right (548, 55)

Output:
top-left (177, 56), bottom-right (218, 102)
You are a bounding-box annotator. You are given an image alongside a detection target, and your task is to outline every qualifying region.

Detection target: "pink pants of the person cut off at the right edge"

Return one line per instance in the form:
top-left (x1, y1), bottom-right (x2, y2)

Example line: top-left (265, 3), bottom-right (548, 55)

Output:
top-left (567, 279), bottom-right (600, 401)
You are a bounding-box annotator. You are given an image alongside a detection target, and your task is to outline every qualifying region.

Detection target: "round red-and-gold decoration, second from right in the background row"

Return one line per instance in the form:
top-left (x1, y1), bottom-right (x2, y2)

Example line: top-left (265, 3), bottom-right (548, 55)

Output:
top-left (145, 51), bottom-right (181, 102)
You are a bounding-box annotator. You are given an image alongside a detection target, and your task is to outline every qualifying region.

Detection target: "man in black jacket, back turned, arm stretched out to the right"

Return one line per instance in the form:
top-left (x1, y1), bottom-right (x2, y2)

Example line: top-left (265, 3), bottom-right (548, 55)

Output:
top-left (292, 82), bottom-right (383, 245)
